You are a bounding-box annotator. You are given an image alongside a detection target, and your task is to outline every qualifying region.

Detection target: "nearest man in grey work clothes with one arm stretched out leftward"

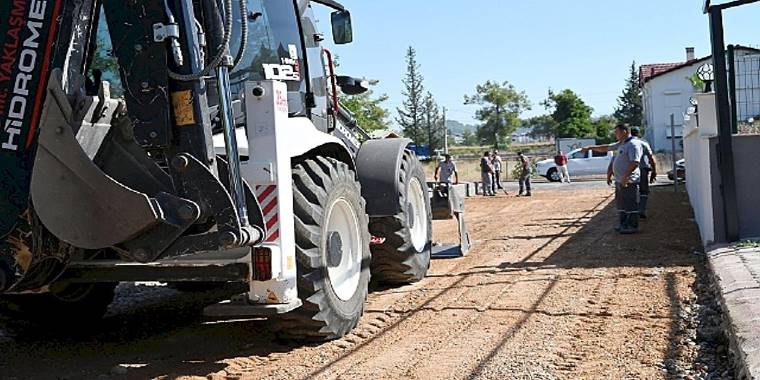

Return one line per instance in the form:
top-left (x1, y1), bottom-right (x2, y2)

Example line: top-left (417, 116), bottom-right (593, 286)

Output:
top-left (583, 124), bottom-right (643, 234)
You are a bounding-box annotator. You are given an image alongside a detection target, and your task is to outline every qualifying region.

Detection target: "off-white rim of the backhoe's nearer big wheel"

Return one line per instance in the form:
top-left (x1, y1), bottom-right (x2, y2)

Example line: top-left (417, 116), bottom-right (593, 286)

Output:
top-left (323, 198), bottom-right (362, 301)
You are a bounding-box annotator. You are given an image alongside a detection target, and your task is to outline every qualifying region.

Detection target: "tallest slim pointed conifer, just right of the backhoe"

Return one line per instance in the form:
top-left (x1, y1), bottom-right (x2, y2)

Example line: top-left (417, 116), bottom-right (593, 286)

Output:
top-left (396, 46), bottom-right (425, 144)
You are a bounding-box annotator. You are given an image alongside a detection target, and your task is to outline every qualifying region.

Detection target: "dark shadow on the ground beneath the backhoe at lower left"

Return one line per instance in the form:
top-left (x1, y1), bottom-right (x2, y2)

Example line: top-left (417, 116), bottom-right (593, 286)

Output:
top-left (0, 288), bottom-right (304, 379)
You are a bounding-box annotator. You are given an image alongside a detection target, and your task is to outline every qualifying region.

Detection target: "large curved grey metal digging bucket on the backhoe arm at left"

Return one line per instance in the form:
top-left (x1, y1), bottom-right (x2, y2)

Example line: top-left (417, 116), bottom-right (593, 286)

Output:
top-left (31, 72), bottom-right (158, 249)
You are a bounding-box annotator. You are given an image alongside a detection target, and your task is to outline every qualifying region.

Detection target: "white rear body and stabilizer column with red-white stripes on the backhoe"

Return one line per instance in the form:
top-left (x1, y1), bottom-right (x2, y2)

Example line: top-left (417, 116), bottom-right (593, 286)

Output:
top-left (229, 81), bottom-right (348, 304)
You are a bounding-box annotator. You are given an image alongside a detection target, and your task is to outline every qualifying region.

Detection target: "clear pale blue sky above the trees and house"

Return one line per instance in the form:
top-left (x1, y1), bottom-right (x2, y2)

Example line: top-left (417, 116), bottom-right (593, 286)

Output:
top-left (315, 0), bottom-right (760, 123)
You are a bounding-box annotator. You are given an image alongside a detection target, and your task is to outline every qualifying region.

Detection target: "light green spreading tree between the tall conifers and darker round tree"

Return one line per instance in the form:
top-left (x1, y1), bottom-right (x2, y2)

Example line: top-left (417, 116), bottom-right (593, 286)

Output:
top-left (464, 81), bottom-right (531, 149)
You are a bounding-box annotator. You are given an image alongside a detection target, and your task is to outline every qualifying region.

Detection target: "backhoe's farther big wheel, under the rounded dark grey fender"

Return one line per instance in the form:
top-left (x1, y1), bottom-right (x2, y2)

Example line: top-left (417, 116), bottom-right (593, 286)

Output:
top-left (370, 150), bottom-right (433, 284)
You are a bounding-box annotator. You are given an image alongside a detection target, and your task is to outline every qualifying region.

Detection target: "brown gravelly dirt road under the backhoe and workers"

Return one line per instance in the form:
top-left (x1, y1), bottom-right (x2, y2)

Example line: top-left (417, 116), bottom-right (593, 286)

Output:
top-left (0, 186), bottom-right (724, 379)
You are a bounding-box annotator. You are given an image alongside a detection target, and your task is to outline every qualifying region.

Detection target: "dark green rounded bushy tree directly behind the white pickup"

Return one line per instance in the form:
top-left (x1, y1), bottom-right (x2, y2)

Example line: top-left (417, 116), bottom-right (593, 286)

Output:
top-left (543, 89), bottom-right (596, 137)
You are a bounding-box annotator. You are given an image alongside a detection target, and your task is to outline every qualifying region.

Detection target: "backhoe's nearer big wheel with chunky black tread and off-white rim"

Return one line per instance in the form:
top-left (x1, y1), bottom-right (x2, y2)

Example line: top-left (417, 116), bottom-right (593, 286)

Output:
top-left (273, 156), bottom-right (370, 341)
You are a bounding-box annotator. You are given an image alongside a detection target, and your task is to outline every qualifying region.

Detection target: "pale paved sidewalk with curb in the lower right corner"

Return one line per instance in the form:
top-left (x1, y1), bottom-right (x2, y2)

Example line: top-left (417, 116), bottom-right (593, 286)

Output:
top-left (707, 245), bottom-right (760, 379)
